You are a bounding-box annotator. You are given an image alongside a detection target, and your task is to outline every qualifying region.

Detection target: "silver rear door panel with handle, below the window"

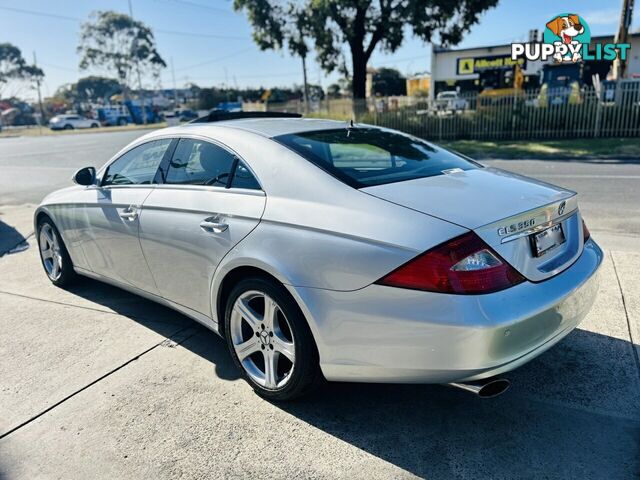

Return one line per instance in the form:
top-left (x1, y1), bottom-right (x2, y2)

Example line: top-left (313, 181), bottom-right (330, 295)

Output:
top-left (140, 185), bottom-right (266, 316)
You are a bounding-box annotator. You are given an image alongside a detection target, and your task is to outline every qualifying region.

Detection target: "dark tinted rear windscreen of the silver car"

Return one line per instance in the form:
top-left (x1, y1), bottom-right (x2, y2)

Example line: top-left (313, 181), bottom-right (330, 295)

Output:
top-left (275, 128), bottom-right (479, 188)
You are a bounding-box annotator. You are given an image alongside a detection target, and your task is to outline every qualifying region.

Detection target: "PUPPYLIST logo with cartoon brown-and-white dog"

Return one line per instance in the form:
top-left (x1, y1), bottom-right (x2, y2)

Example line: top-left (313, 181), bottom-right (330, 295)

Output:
top-left (511, 13), bottom-right (631, 63)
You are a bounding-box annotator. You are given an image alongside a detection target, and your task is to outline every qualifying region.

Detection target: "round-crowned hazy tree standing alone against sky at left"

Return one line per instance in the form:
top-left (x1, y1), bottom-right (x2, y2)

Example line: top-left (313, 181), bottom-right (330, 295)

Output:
top-left (77, 11), bottom-right (167, 91)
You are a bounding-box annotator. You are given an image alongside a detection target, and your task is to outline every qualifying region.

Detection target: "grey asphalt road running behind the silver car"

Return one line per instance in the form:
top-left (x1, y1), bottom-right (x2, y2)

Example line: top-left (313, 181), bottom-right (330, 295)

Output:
top-left (0, 131), bottom-right (640, 251)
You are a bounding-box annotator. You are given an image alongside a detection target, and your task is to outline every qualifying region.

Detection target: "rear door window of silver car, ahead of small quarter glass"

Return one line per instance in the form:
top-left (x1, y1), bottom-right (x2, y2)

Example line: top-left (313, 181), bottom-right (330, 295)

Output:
top-left (165, 138), bottom-right (236, 187)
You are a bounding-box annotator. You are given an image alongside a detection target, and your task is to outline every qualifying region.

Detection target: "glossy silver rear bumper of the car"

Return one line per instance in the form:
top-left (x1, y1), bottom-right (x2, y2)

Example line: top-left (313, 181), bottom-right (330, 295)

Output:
top-left (290, 240), bottom-right (603, 383)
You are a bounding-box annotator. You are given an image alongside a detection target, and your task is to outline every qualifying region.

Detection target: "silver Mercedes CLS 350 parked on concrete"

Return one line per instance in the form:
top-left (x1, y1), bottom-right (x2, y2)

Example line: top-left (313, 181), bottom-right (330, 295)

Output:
top-left (34, 112), bottom-right (603, 400)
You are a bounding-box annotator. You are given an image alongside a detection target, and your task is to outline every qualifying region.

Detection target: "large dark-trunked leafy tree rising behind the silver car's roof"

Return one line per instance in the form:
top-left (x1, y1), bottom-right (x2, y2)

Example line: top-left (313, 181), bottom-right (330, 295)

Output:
top-left (234, 0), bottom-right (498, 99)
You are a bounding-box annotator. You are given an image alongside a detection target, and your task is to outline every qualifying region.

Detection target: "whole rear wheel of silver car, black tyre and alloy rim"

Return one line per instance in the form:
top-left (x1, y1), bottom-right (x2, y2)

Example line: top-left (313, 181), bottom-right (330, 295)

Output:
top-left (224, 277), bottom-right (324, 401)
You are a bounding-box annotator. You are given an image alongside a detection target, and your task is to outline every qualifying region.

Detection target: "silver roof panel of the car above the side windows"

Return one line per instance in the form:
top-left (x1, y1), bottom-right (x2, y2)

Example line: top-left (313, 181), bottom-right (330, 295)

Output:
top-left (178, 118), bottom-right (356, 138)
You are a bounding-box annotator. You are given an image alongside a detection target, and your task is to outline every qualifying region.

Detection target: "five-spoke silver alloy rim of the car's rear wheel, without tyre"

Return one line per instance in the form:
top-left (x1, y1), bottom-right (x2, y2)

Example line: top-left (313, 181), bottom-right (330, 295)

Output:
top-left (230, 290), bottom-right (295, 390)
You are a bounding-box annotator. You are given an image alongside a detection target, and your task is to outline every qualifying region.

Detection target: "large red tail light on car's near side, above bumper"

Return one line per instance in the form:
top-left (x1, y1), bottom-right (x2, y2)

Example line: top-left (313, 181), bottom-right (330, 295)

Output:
top-left (376, 232), bottom-right (524, 294)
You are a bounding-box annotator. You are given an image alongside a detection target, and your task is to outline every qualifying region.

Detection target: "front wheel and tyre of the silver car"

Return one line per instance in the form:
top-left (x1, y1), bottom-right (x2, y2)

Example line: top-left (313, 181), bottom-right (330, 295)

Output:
top-left (37, 217), bottom-right (78, 287)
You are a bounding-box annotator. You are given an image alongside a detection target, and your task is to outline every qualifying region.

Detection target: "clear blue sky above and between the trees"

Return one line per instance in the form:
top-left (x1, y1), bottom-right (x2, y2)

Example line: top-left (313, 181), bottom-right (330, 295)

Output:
top-left (0, 0), bottom-right (640, 97)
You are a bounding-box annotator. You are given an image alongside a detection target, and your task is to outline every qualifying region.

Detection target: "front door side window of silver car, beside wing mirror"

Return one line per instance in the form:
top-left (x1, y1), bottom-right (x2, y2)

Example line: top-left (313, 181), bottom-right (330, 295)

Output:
top-left (102, 138), bottom-right (171, 186)
